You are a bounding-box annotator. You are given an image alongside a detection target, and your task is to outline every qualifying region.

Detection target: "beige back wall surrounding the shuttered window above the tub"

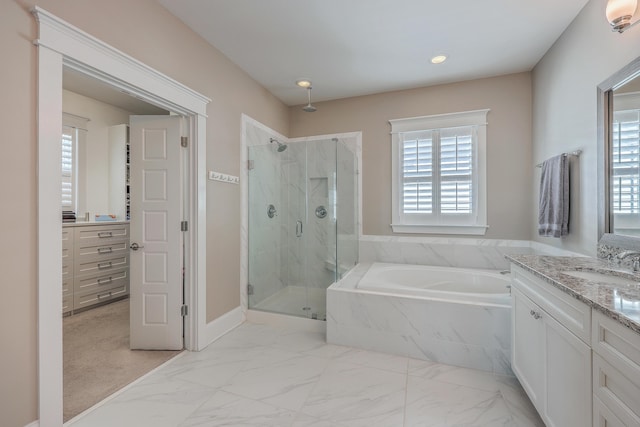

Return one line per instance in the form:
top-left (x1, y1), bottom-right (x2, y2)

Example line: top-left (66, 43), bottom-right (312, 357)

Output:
top-left (290, 73), bottom-right (533, 239)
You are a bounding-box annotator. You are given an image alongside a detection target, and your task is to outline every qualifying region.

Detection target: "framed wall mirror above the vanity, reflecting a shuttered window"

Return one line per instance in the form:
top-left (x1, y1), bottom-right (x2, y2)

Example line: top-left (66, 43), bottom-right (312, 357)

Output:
top-left (598, 58), bottom-right (640, 239)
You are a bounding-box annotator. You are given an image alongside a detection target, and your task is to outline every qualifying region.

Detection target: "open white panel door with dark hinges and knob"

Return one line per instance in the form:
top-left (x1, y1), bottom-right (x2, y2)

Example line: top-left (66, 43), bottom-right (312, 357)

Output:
top-left (129, 116), bottom-right (183, 350)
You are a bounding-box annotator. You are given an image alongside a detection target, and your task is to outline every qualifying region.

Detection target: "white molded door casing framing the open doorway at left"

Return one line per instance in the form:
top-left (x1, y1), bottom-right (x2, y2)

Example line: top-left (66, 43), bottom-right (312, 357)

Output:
top-left (33, 7), bottom-right (210, 426)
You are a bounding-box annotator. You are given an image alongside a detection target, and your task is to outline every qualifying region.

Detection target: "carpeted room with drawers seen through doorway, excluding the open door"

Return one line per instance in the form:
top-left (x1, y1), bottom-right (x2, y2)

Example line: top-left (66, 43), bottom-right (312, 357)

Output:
top-left (62, 67), bottom-right (188, 422)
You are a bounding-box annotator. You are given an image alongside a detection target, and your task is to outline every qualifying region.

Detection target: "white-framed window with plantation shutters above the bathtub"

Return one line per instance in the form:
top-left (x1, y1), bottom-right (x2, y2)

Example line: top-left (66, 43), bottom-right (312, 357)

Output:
top-left (389, 110), bottom-right (489, 235)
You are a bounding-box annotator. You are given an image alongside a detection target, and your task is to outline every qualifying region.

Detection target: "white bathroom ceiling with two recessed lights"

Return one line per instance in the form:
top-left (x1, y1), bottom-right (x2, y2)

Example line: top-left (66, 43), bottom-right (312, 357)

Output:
top-left (158, 0), bottom-right (588, 105)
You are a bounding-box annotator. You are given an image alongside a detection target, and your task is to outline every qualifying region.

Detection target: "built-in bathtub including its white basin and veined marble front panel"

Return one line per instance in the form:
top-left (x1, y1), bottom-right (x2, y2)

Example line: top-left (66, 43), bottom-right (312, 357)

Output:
top-left (327, 263), bottom-right (512, 375)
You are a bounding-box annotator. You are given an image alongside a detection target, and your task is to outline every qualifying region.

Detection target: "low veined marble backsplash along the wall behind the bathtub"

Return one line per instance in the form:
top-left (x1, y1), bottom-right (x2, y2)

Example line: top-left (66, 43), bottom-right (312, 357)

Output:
top-left (359, 235), bottom-right (578, 270)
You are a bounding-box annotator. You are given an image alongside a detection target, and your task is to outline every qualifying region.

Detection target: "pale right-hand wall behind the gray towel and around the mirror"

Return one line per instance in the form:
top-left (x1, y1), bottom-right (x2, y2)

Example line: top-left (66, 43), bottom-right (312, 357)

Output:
top-left (530, 0), bottom-right (640, 255)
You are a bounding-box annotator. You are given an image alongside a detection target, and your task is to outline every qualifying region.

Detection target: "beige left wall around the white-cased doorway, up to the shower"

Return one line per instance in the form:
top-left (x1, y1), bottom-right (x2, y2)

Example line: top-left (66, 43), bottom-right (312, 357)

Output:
top-left (0, 0), bottom-right (289, 427)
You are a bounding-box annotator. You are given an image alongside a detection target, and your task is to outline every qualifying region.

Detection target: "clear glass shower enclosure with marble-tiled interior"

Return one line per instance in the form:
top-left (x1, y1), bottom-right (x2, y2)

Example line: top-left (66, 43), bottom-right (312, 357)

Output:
top-left (248, 138), bottom-right (358, 320)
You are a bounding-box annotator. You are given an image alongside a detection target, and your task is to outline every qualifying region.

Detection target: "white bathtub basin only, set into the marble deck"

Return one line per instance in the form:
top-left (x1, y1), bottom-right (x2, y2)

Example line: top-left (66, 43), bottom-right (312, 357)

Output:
top-left (356, 263), bottom-right (511, 306)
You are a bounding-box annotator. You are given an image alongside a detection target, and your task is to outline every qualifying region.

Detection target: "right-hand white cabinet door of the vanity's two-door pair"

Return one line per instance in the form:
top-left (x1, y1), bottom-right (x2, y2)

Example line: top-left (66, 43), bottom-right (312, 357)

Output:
top-left (539, 312), bottom-right (593, 427)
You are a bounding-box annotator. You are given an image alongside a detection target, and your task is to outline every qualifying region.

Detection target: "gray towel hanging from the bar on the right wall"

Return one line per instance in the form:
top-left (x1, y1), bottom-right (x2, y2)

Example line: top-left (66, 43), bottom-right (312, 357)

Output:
top-left (538, 154), bottom-right (569, 237)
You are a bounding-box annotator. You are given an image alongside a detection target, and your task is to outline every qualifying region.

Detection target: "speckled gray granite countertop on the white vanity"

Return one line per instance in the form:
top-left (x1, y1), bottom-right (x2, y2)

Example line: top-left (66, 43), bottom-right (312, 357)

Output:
top-left (506, 255), bottom-right (640, 334)
